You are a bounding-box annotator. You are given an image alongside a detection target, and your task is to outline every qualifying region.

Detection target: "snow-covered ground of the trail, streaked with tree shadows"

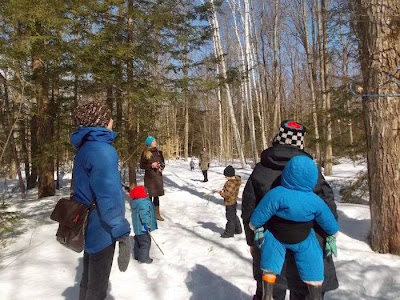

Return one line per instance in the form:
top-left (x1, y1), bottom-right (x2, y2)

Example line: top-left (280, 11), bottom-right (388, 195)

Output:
top-left (0, 160), bottom-right (400, 300)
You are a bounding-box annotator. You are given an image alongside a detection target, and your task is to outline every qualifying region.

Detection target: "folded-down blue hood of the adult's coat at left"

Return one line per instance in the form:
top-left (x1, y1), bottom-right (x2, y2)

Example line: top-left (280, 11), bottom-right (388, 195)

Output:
top-left (71, 126), bottom-right (117, 149)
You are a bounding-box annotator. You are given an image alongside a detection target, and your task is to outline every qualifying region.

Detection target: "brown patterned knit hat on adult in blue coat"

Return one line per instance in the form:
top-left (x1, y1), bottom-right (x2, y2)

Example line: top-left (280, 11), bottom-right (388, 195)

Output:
top-left (75, 101), bottom-right (111, 127)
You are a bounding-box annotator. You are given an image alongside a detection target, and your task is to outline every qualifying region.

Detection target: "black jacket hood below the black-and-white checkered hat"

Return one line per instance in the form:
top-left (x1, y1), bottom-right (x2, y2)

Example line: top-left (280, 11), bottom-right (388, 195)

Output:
top-left (261, 144), bottom-right (311, 170)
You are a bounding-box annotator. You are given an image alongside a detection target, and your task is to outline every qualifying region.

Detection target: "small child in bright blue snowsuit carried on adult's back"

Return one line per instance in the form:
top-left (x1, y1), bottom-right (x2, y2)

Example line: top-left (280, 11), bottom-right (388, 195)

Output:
top-left (250, 155), bottom-right (339, 300)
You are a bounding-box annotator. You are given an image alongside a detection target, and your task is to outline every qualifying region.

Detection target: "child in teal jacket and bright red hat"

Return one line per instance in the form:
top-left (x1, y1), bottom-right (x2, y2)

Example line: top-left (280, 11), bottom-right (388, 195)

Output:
top-left (129, 185), bottom-right (157, 264)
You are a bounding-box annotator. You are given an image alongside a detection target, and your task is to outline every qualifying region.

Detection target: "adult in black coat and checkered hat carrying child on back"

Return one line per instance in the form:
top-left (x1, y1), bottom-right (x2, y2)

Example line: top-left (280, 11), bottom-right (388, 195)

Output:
top-left (242, 120), bottom-right (339, 300)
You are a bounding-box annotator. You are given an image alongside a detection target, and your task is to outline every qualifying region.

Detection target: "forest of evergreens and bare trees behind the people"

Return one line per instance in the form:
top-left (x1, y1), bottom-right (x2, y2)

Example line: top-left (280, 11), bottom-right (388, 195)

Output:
top-left (0, 0), bottom-right (400, 254)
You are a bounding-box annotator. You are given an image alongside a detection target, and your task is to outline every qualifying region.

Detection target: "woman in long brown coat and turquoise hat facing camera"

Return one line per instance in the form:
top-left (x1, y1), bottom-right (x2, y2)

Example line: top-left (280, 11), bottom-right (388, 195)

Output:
top-left (140, 136), bottom-right (165, 221)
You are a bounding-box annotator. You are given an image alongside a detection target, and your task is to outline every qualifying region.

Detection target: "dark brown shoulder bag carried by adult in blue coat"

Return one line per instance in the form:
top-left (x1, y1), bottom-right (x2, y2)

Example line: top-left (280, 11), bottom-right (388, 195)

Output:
top-left (50, 195), bottom-right (95, 253)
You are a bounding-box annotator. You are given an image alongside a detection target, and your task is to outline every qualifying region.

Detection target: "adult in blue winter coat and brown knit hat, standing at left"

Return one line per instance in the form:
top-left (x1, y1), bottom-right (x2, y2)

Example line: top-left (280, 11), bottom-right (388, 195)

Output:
top-left (71, 102), bottom-right (130, 300)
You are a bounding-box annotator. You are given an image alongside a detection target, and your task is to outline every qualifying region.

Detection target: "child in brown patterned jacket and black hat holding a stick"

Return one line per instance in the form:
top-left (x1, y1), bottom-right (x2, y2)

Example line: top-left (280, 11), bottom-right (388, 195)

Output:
top-left (219, 166), bottom-right (243, 238)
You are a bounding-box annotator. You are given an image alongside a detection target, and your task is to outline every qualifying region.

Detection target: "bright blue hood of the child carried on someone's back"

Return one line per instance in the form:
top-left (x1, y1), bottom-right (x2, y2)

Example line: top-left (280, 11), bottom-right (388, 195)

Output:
top-left (281, 155), bottom-right (318, 192)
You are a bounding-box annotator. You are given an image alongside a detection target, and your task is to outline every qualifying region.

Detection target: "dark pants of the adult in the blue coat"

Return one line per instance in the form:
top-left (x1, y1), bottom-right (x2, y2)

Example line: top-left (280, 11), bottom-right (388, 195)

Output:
top-left (79, 244), bottom-right (115, 300)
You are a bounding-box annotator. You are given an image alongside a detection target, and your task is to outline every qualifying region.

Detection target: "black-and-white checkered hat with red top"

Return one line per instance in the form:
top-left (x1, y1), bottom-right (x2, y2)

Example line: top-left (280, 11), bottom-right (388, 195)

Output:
top-left (273, 120), bottom-right (306, 150)
